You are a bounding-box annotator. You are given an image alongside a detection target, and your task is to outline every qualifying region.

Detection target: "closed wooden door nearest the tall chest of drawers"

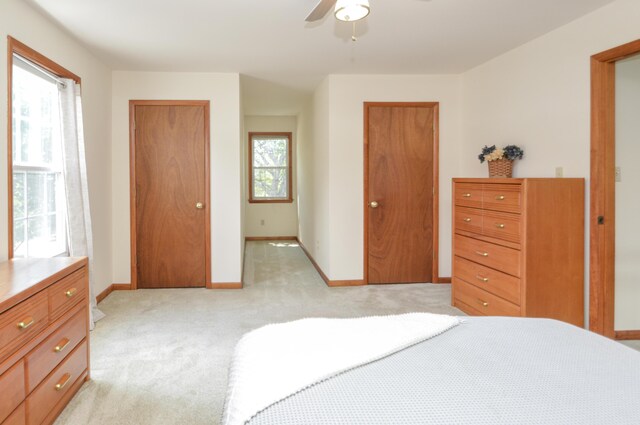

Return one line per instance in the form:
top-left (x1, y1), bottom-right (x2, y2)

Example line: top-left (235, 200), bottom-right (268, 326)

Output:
top-left (365, 105), bottom-right (436, 283)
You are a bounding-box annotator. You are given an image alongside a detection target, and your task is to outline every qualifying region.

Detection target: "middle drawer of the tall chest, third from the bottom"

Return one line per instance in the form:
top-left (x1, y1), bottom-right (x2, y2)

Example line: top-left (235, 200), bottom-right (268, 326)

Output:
top-left (454, 235), bottom-right (520, 277)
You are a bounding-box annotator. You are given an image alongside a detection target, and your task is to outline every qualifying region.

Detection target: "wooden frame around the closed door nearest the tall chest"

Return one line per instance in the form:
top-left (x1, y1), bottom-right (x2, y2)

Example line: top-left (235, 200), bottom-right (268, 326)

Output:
top-left (363, 102), bottom-right (440, 285)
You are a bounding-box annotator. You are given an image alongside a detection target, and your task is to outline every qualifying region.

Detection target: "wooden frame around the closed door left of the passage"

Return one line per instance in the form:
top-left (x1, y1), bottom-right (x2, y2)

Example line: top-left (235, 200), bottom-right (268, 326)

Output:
top-left (129, 100), bottom-right (211, 289)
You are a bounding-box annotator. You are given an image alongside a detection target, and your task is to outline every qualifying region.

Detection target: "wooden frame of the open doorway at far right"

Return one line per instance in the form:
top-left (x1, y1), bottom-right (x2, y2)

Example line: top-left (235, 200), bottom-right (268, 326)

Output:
top-left (589, 39), bottom-right (640, 338)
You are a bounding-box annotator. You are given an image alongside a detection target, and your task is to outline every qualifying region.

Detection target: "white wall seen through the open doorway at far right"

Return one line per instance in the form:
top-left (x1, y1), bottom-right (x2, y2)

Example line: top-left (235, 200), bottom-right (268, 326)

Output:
top-left (615, 55), bottom-right (640, 330)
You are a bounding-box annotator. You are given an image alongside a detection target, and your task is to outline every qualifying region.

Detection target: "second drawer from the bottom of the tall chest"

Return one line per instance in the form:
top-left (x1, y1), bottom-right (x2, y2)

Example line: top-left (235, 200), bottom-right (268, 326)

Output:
top-left (453, 257), bottom-right (520, 305)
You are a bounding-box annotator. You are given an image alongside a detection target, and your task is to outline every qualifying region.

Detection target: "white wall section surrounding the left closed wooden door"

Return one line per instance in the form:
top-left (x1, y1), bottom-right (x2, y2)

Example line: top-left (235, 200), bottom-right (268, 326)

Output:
top-left (112, 71), bottom-right (243, 283)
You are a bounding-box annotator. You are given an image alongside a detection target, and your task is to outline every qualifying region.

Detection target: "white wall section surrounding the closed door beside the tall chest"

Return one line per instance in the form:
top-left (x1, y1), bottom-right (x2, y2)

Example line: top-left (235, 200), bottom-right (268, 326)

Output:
top-left (325, 75), bottom-right (462, 280)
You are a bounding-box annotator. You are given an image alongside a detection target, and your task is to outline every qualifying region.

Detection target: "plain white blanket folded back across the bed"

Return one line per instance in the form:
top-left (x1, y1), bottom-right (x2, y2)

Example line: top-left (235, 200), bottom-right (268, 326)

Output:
top-left (222, 313), bottom-right (460, 425)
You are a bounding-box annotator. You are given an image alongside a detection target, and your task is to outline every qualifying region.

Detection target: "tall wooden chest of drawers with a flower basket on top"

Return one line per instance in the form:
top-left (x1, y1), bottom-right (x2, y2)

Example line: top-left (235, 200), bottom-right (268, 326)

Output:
top-left (452, 178), bottom-right (584, 326)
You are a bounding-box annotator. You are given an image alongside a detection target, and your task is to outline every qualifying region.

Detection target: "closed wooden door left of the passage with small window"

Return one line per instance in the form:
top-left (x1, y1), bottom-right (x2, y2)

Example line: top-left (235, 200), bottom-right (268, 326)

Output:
top-left (133, 105), bottom-right (209, 288)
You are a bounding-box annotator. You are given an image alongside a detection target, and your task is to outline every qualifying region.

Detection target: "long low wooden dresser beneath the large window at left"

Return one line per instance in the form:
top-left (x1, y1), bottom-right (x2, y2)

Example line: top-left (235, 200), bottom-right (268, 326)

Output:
top-left (0, 257), bottom-right (89, 425)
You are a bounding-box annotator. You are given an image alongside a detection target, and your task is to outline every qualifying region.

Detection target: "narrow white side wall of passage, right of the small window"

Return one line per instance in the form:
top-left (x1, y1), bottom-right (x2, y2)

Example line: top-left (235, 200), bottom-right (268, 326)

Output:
top-left (297, 78), bottom-right (332, 275)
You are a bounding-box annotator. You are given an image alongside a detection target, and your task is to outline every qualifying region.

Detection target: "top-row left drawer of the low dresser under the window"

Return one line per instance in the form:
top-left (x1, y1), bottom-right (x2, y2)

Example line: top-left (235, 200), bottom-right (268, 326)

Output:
top-left (0, 292), bottom-right (49, 361)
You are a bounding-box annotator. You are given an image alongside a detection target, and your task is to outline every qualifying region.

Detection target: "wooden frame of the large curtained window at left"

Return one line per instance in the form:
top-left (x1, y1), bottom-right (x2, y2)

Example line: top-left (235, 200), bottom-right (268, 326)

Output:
top-left (7, 36), bottom-right (81, 259)
